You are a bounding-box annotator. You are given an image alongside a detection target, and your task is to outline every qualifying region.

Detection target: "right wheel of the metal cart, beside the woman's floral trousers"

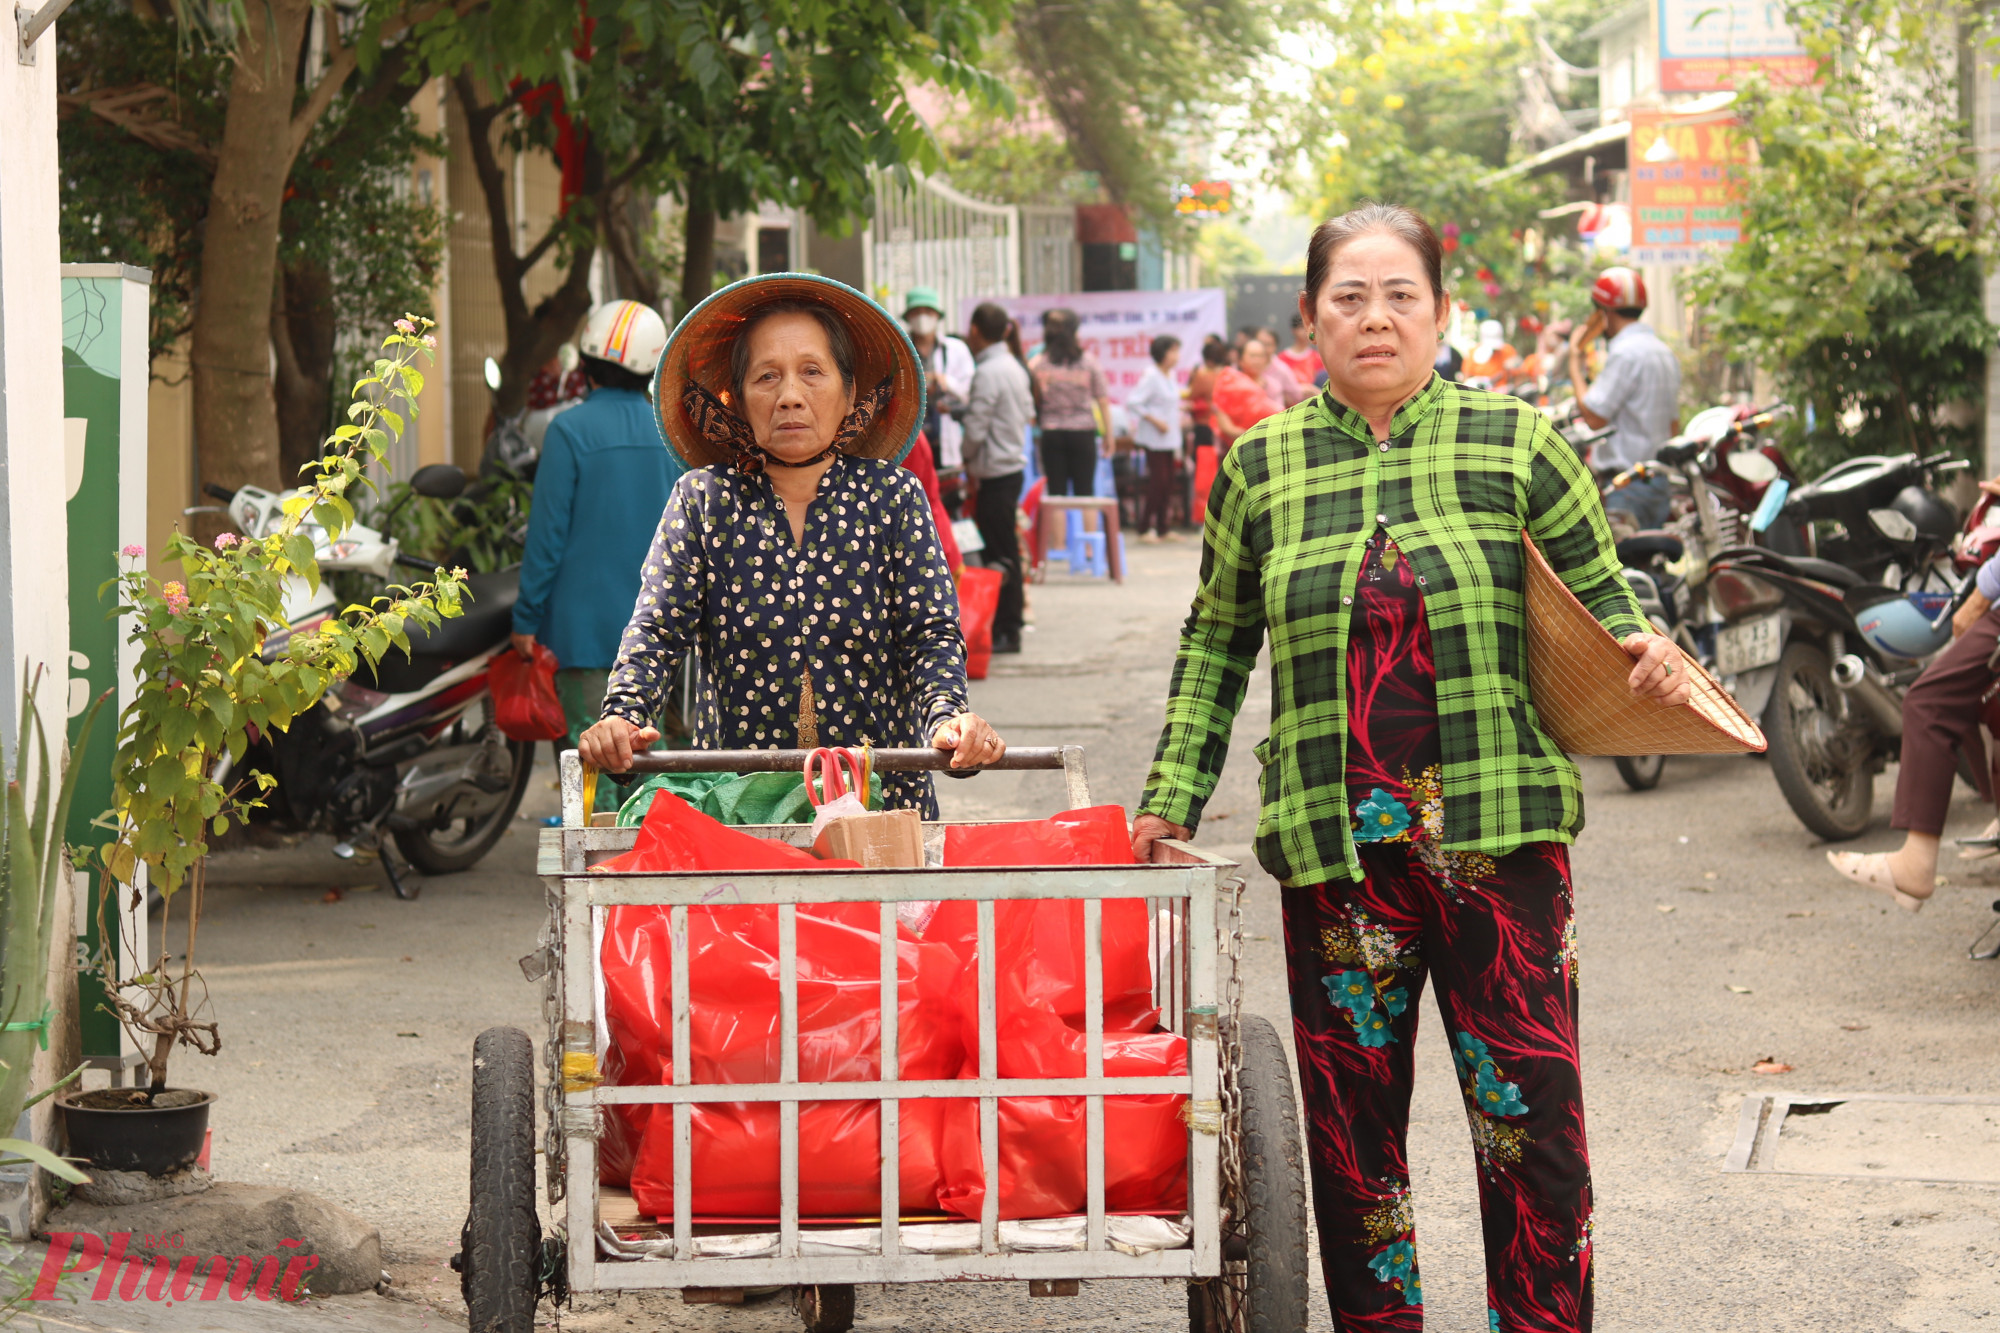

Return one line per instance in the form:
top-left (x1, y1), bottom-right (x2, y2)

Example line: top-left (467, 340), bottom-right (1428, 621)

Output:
top-left (1188, 1013), bottom-right (1308, 1333)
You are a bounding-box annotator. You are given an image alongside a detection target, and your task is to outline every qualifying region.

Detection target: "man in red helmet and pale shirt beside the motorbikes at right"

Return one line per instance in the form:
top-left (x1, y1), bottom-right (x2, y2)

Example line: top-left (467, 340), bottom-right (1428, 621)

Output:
top-left (1570, 264), bottom-right (1680, 530)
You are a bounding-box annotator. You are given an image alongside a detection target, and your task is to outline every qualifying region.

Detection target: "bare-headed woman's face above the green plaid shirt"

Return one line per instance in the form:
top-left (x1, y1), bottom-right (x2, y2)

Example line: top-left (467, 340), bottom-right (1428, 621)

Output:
top-left (1298, 232), bottom-right (1450, 408)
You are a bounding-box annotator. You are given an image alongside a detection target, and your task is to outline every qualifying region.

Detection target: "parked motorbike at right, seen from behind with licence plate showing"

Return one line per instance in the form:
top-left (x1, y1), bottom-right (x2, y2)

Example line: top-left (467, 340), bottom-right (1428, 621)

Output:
top-left (1710, 454), bottom-right (1970, 841)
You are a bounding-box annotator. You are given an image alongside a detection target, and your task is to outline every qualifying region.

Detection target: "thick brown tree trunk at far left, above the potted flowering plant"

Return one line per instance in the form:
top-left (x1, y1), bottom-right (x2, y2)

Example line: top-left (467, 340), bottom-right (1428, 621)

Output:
top-left (192, 0), bottom-right (312, 488)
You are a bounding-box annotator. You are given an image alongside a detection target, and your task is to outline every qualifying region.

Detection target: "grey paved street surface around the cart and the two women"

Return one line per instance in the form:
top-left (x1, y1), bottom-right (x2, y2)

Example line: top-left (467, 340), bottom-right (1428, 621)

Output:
top-left (39, 542), bottom-right (2000, 1333)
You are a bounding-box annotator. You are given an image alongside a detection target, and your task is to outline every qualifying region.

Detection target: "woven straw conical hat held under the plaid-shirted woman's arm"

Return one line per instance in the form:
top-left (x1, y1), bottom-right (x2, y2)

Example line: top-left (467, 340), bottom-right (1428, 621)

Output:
top-left (1520, 532), bottom-right (1764, 755)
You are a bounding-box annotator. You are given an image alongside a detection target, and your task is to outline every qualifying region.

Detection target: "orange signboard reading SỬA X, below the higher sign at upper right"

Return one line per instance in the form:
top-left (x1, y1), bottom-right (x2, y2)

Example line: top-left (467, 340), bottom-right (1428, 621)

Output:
top-left (1628, 110), bottom-right (1748, 266)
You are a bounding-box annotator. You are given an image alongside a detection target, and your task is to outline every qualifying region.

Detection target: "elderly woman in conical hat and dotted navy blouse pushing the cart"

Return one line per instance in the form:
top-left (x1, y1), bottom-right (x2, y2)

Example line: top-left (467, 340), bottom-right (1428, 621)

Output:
top-left (578, 274), bottom-right (1006, 804)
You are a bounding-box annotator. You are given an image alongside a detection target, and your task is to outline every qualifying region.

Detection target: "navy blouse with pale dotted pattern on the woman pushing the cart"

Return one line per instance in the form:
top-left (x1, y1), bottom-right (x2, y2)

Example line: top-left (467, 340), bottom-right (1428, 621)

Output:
top-left (604, 456), bottom-right (968, 819)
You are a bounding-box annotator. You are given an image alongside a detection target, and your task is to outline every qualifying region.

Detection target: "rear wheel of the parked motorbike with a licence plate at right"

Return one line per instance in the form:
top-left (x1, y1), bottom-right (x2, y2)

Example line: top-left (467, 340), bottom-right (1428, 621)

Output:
top-left (1764, 640), bottom-right (1874, 843)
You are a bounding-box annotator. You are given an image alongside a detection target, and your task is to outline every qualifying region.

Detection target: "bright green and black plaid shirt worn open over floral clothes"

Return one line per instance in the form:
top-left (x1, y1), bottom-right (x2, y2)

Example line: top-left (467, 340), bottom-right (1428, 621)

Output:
top-left (1140, 376), bottom-right (1652, 885)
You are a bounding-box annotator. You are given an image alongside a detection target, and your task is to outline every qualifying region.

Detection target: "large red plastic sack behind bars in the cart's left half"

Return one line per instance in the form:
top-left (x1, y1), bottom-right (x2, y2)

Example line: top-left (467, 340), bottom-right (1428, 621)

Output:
top-left (600, 903), bottom-right (964, 1221)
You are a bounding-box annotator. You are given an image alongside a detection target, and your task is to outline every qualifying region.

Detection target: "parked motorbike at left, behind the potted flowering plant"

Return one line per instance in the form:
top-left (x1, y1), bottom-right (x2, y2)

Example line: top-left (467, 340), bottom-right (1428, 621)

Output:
top-left (208, 464), bottom-right (534, 899)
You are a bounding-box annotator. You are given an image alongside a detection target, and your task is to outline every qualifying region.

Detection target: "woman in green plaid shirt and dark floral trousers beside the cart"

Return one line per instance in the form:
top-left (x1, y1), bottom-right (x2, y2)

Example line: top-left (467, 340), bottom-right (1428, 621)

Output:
top-left (1134, 204), bottom-right (1686, 1333)
